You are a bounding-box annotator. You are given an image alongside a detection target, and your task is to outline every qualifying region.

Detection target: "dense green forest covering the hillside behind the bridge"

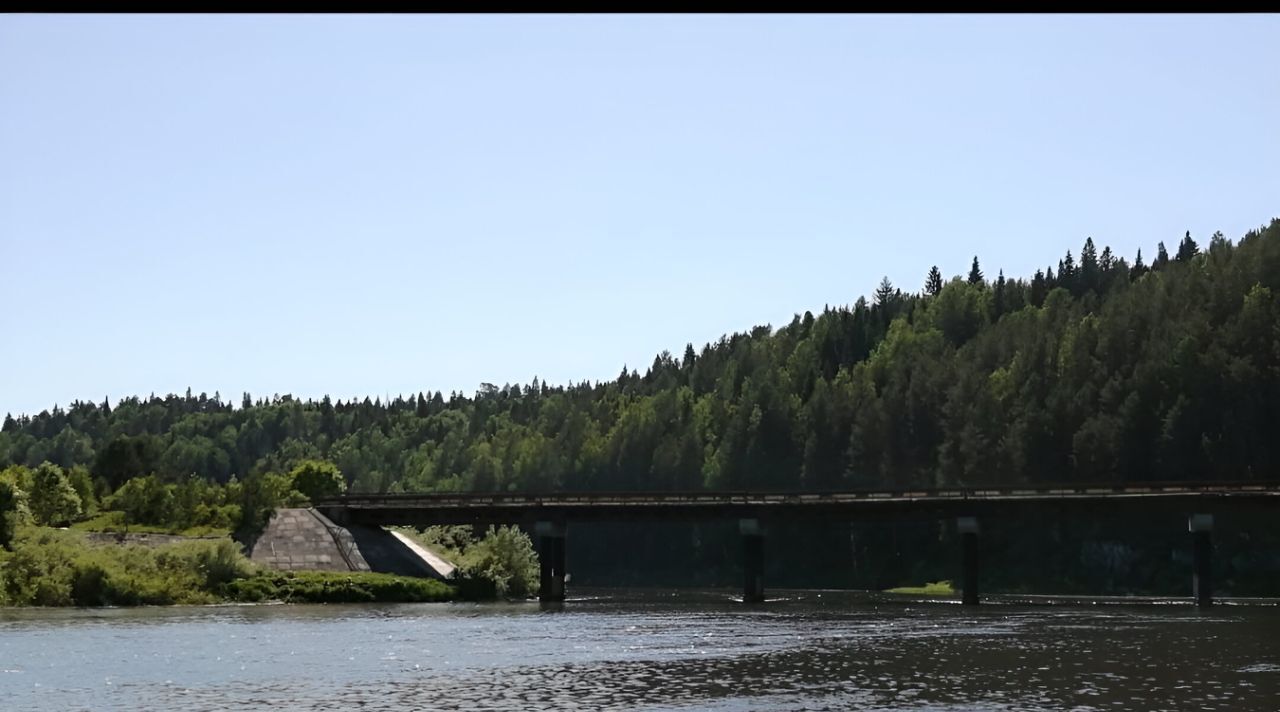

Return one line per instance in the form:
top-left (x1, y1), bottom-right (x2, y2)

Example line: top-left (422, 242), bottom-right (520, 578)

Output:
top-left (0, 220), bottom-right (1280, 593)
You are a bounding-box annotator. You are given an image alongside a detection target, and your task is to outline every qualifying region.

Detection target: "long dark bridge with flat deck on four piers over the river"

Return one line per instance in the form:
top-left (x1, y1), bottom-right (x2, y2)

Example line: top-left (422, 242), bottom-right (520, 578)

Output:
top-left (315, 481), bottom-right (1280, 607)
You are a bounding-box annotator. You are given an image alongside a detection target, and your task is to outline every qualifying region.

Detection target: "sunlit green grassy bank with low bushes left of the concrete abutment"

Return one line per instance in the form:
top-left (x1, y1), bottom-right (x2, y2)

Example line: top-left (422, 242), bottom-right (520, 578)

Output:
top-left (0, 526), bottom-right (477, 606)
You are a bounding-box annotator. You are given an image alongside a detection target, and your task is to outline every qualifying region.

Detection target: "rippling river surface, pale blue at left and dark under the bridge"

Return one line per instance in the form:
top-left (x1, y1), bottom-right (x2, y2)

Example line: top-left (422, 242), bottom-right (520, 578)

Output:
top-left (0, 590), bottom-right (1280, 712)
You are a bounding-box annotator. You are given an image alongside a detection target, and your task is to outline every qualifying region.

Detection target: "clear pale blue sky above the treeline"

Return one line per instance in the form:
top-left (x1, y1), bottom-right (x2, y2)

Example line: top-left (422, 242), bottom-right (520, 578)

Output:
top-left (0, 15), bottom-right (1280, 414)
